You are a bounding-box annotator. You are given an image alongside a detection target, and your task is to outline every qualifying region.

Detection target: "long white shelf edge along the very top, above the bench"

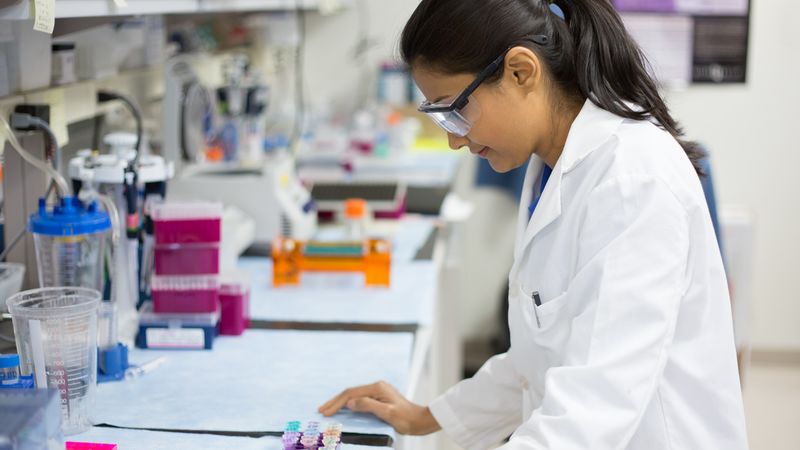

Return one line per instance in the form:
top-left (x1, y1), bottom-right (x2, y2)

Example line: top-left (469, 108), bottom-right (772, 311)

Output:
top-left (0, 0), bottom-right (324, 20)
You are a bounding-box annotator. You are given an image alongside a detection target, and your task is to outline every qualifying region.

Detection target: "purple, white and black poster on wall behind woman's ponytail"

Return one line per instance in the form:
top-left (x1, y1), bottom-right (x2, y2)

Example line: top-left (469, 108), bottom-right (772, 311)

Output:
top-left (613, 0), bottom-right (750, 86)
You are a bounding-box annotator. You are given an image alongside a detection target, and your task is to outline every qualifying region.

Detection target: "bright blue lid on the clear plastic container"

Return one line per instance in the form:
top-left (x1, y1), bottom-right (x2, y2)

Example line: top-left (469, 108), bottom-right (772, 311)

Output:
top-left (28, 197), bottom-right (111, 236)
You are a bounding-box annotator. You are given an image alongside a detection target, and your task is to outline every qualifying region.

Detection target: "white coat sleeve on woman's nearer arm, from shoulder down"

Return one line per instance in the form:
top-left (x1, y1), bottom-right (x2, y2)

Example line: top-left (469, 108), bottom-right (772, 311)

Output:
top-left (501, 175), bottom-right (689, 450)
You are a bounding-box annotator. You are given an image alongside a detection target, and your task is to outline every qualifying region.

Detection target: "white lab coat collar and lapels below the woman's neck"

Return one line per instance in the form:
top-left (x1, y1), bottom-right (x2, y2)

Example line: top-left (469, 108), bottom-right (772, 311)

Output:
top-left (512, 100), bottom-right (625, 273)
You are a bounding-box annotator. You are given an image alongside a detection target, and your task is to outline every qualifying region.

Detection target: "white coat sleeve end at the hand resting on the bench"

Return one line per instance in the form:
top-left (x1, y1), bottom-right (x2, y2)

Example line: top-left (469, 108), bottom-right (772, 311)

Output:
top-left (429, 353), bottom-right (522, 449)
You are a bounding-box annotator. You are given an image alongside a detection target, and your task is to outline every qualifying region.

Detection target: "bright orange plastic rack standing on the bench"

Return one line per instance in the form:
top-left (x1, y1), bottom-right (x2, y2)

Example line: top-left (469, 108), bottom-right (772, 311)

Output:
top-left (272, 237), bottom-right (392, 287)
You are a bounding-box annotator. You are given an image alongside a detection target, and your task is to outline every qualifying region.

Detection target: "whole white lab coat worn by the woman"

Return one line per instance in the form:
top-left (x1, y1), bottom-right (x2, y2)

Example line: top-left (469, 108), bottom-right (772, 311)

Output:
top-left (430, 101), bottom-right (747, 450)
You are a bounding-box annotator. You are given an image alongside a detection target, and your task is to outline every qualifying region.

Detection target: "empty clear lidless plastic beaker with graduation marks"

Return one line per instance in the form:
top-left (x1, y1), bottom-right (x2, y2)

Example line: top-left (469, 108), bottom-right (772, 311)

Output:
top-left (6, 287), bottom-right (101, 435)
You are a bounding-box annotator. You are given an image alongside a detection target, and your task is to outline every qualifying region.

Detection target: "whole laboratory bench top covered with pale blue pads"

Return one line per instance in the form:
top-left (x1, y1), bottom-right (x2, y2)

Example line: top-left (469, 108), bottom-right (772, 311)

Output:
top-left (80, 216), bottom-right (454, 450)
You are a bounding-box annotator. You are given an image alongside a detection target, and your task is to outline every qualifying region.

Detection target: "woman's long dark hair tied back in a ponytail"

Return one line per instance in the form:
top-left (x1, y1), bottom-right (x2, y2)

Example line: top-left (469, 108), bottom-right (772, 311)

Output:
top-left (400, 0), bottom-right (703, 175)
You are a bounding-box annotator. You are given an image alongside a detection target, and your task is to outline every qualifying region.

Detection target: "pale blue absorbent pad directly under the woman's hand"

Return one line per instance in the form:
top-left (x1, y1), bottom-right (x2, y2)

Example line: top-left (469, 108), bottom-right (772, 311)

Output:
top-left (95, 330), bottom-right (413, 437)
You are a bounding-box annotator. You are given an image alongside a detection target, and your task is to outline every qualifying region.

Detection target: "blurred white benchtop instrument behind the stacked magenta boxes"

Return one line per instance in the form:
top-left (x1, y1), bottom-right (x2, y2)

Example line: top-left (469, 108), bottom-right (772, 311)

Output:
top-left (168, 153), bottom-right (317, 244)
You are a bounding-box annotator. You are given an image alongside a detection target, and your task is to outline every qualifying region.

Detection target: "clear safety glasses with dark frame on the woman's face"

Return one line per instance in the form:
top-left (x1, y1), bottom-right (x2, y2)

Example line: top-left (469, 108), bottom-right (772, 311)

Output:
top-left (417, 35), bottom-right (550, 137)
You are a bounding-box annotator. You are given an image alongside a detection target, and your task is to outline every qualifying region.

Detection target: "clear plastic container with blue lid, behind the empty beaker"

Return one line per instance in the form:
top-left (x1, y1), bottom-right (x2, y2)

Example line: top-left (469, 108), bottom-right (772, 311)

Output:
top-left (28, 197), bottom-right (111, 292)
